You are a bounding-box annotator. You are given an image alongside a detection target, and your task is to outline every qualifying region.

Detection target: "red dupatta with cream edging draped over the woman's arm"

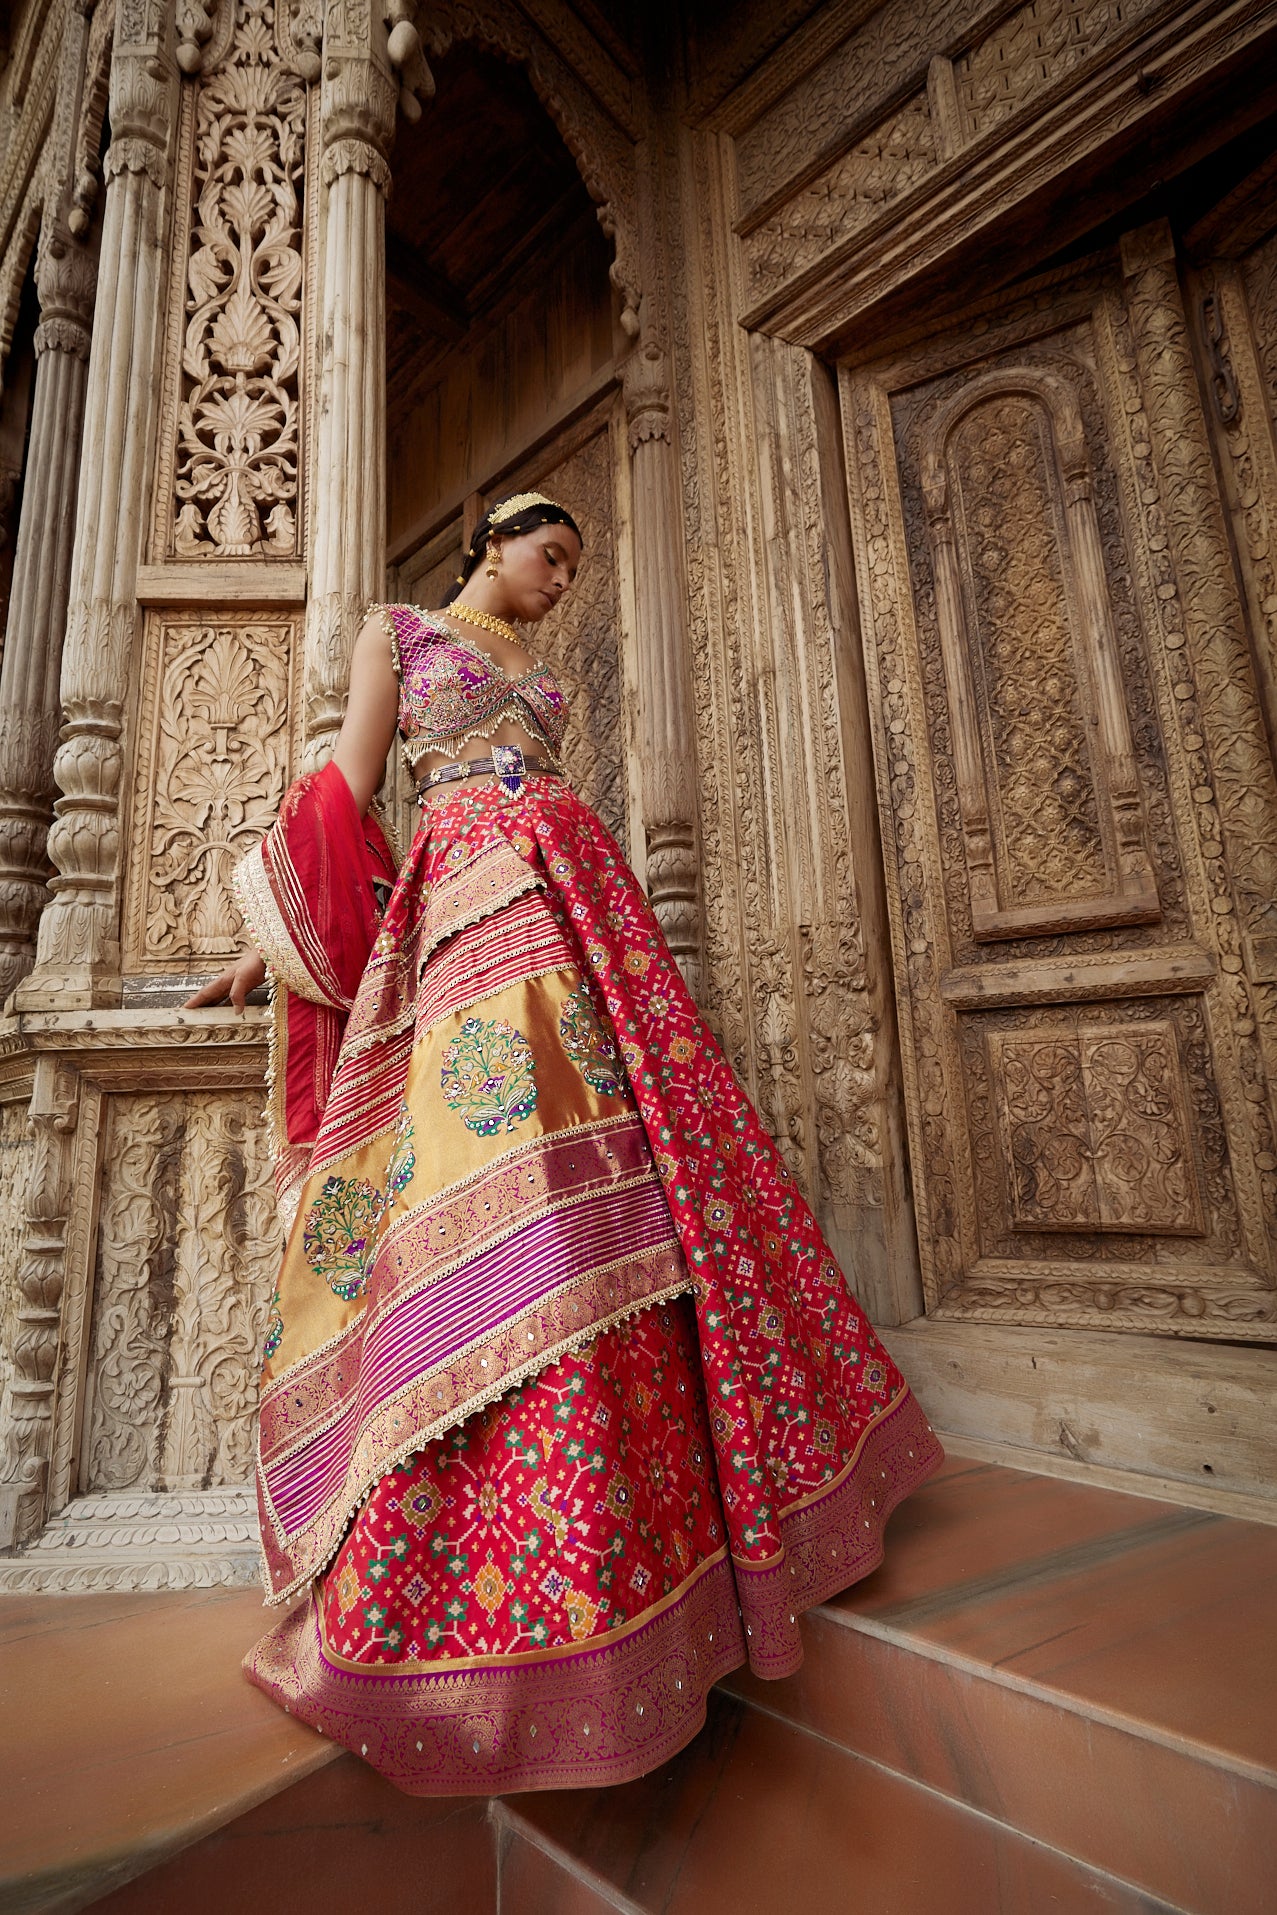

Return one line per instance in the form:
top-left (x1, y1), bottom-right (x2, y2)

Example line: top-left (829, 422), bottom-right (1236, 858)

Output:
top-left (234, 762), bottom-right (396, 1224)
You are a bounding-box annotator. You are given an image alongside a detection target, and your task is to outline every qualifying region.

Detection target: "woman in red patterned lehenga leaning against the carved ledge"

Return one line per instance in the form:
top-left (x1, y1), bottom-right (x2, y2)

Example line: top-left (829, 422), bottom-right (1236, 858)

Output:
top-left (191, 494), bottom-right (940, 1794)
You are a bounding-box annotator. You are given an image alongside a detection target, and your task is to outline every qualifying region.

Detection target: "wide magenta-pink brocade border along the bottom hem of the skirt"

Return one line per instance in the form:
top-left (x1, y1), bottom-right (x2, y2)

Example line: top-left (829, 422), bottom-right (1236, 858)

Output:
top-left (243, 1390), bottom-right (944, 1796)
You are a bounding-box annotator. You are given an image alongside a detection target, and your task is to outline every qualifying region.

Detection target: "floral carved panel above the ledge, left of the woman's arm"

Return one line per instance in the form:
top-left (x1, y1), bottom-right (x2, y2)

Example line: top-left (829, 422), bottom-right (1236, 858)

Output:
top-left (124, 613), bottom-right (299, 975)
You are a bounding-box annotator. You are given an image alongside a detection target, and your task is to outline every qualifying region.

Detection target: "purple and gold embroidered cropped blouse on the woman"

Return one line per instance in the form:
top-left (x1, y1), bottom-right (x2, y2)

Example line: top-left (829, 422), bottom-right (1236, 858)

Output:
top-left (370, 605), bottom-right (567, 768)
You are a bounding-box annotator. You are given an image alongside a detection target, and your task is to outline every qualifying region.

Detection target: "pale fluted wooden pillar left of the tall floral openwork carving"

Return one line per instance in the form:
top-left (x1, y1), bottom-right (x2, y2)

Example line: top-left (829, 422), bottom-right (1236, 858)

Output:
top-left (17, 22), bottom-right (176, 1009)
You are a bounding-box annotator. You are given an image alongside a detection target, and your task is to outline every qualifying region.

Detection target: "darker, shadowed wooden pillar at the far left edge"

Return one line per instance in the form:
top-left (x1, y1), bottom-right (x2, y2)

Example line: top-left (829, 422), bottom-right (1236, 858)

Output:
top-left (0, 224), bottom-right (96, 1003)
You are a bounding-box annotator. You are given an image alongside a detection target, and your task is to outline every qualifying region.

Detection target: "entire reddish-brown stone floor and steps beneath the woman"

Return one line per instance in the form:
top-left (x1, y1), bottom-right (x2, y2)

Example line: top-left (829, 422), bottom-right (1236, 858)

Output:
top-left (0, 1457), bottom-right (1277, 1915)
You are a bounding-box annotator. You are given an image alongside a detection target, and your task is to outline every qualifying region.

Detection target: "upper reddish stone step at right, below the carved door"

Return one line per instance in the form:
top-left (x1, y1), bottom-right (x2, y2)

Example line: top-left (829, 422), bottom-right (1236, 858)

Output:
top-left (728, 1457), bottom-right (1277, 1915)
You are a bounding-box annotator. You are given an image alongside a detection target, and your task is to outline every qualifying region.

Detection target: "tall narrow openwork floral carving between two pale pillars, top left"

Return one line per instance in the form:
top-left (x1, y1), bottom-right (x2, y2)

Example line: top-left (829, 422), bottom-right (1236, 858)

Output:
top-left (168, 0), bottom-right (306, 559)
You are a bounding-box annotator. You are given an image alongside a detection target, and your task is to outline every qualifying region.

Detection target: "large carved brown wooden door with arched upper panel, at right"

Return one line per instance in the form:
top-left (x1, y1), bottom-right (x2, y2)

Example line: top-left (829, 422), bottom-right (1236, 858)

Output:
top-left (842, 226), bottom-right (1277, 1339)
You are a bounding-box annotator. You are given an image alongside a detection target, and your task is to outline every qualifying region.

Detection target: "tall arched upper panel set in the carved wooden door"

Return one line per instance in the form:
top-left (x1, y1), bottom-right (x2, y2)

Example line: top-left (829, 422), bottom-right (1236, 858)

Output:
top-left (911, 366), bottom-right (1158, 938)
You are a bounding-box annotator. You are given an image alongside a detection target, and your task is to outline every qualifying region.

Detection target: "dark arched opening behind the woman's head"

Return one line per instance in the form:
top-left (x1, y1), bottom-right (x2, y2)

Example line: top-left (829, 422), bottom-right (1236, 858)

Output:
top-left (387, 42), bottom-right (641, 854)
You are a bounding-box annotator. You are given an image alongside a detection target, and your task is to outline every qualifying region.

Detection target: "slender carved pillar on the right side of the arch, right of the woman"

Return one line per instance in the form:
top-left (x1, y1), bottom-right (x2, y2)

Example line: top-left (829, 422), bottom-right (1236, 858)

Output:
top-left (624, 339), bottom-right (703, 998)
